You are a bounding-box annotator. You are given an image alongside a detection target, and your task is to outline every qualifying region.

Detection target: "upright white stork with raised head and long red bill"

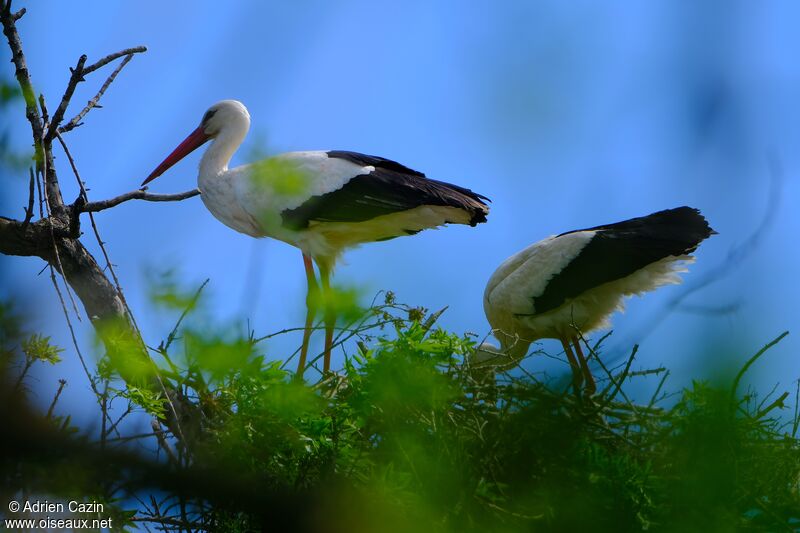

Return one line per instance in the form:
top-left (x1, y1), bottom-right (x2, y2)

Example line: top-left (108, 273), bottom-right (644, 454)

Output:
top-left (142, 100), bottom-right (489, 376)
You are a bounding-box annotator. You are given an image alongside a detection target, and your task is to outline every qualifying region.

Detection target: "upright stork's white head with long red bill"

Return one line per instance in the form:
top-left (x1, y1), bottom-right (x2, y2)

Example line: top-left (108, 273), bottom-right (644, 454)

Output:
top-left (142, 100), bottom-right (250, 185)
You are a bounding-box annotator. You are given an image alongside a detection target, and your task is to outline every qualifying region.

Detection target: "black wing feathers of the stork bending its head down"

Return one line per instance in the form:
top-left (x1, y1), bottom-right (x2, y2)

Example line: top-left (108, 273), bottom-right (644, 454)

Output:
top-left (533, 206), bottom-right (716, 314)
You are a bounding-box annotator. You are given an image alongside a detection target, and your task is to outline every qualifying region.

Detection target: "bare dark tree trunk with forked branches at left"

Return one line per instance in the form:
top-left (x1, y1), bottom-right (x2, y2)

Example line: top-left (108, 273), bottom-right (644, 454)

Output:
top-left (0, 4), bottom-right (199, 448)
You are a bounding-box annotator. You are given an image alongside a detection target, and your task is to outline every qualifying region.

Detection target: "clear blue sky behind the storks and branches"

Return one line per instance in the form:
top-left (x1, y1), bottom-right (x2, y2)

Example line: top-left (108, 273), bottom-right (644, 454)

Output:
top-left (0, 1), bottom-right (800, 424)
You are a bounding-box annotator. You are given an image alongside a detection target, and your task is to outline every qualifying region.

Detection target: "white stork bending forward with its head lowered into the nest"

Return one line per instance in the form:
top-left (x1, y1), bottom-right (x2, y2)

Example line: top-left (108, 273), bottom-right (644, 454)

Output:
top-left (474, 207), bottom-right (716, 394)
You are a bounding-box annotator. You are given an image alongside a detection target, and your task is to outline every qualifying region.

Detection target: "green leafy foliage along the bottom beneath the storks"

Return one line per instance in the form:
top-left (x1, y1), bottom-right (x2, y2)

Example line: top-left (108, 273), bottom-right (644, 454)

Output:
top-left (3, 291), bottom-right (800, 532)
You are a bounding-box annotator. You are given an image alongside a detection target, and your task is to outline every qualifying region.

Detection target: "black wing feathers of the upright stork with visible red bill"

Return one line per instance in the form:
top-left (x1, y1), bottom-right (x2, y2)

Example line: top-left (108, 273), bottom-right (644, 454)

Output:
top-left (281, 151), bottom-right (489, 229)
